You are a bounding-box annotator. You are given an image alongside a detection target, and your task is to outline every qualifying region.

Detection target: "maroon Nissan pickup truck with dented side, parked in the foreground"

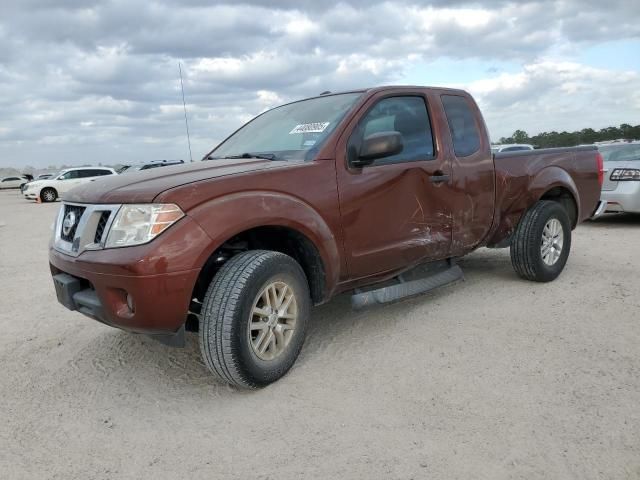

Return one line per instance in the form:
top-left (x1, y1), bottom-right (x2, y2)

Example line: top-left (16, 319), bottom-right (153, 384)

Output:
top-left (49, 87), bottom-right (603, 388)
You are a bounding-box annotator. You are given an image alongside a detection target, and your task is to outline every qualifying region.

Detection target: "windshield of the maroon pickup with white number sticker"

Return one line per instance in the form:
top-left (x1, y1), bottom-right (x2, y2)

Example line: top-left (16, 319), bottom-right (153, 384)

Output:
top-left (208, 93), bottom-right (361, 161)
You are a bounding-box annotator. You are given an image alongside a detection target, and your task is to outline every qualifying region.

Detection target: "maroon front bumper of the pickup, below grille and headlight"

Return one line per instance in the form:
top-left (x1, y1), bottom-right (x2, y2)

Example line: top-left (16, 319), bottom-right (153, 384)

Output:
top-left (49, 217), bottom-right (211, 335)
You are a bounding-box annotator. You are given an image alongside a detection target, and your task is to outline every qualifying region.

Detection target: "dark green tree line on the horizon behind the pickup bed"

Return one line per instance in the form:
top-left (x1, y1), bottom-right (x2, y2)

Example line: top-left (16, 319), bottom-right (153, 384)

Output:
top-left (500, 123), bottom-right (640, 148)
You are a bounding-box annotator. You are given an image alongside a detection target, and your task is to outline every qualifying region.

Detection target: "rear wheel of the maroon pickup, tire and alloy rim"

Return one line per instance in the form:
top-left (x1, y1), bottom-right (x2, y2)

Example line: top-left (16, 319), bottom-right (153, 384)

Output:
top-left (511, 200), bottom-right (571, 282)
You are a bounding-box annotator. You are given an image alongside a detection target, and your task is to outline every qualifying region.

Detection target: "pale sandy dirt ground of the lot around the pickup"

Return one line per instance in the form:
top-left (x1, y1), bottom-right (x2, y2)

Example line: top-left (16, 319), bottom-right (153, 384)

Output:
top-left (0, 188), bottom-right (640, 480)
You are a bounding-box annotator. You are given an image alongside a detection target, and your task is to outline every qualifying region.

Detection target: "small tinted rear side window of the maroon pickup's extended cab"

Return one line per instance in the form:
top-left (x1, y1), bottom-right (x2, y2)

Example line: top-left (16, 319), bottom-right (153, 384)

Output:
top-left (442, 95), bottom-right (480, 157)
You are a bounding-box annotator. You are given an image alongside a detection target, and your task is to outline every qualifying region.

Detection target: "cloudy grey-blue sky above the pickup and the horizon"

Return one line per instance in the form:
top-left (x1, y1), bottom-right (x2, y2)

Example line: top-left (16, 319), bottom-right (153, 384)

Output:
top-left (0, 0), bottom-right (640, 167)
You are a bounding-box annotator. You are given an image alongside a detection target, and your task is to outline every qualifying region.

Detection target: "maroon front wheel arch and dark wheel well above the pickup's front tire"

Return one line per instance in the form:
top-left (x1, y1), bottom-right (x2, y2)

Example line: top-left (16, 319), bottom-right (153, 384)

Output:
top-left (188, 192), bottom-right (341, 316)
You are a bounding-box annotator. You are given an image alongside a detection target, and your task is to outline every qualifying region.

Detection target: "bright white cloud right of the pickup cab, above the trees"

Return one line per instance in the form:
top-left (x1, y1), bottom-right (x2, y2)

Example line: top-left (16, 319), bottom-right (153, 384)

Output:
top-left (466, 61), bottom-right (640, 139)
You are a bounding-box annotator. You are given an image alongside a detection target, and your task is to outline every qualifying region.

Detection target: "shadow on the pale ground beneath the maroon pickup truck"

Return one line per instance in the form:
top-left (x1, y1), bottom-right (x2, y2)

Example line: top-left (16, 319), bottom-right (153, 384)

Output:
top-left (72, 250), bottom-right (518, 398)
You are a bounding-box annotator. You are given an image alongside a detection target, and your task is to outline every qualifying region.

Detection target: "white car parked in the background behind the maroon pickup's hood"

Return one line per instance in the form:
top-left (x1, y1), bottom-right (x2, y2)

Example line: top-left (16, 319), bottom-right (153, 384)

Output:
top-left (22, 167), bottom-right (117, 202)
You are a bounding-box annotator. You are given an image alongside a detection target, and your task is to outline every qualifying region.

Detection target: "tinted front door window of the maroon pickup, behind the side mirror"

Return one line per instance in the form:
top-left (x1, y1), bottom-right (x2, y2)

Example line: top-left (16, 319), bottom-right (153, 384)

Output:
top-left (348, 97), bottom-right (433, 165)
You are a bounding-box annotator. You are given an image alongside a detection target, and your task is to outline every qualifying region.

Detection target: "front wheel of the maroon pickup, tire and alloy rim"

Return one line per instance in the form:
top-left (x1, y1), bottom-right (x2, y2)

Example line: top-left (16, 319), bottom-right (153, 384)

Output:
top-left (199, 250), bottom-right (311, 388)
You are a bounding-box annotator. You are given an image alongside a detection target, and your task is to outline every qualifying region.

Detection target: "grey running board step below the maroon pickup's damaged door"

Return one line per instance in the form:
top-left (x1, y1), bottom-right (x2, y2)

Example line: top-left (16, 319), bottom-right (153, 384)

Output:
top-left (351, 265), bottom-right (464, 310)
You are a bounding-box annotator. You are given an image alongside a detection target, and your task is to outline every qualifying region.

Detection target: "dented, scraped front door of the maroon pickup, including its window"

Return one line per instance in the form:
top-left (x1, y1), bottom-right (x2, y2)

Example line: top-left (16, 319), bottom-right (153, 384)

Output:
top-left (336, 92), bottom-right (452, 279)
